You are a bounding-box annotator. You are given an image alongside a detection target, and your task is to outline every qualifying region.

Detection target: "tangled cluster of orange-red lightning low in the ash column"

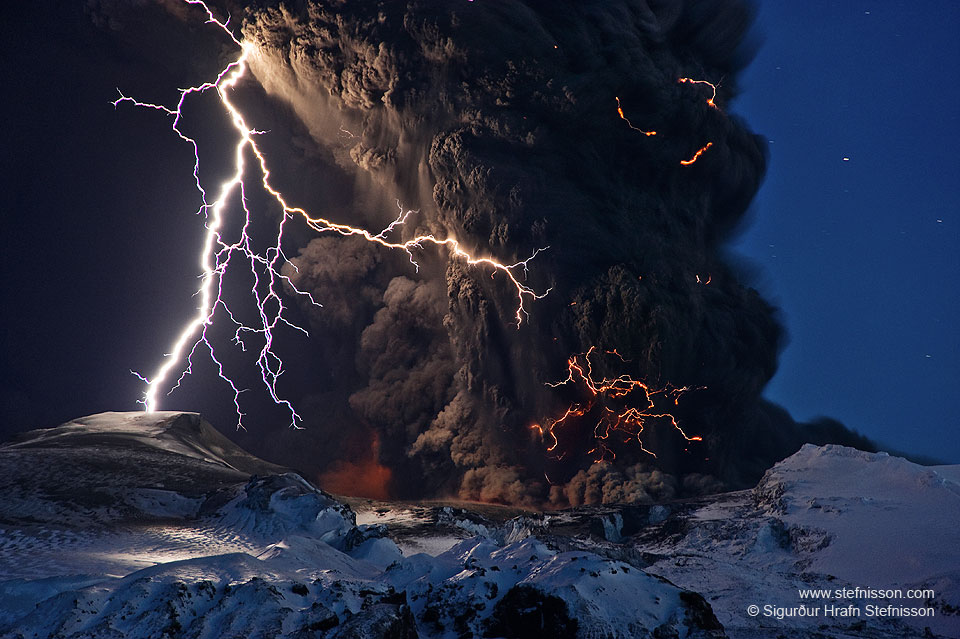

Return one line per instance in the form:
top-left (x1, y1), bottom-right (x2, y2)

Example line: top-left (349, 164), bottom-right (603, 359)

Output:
top-left (530, 346), bottom-right (702, 462)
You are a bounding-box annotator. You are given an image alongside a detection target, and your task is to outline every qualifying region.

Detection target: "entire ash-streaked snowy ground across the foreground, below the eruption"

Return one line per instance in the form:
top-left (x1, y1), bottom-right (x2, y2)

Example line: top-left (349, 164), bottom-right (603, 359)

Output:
top-left (0, 413), bottom-right (960, 639)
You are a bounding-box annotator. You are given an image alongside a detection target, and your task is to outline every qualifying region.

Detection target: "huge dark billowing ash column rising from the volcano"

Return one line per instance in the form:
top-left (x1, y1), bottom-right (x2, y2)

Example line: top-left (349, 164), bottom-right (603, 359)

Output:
top-left (221, 0), bottom-right (863, 506)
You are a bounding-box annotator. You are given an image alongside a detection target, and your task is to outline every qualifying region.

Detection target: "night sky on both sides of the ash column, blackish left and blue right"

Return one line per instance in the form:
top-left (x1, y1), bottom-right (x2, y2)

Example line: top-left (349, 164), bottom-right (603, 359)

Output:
top-left (0, 1), bottom-right (960, 462)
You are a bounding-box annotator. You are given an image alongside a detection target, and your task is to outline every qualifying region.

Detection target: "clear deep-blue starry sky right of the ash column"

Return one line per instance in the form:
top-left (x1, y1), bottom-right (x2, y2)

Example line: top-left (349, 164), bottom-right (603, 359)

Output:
top-left (732, 0), bottom-right (960, 462)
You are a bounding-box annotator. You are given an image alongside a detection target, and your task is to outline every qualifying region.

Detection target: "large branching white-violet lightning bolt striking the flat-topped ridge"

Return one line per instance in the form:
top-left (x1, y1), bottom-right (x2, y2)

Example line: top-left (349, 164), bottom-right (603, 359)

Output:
top-left (120, 0), bottom-right (550, 428)
